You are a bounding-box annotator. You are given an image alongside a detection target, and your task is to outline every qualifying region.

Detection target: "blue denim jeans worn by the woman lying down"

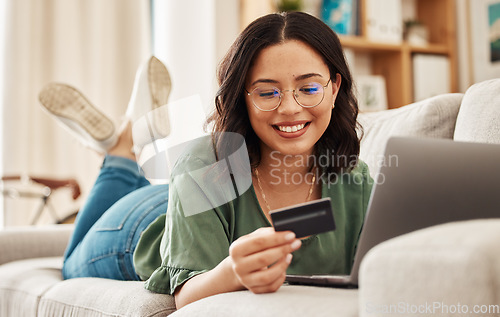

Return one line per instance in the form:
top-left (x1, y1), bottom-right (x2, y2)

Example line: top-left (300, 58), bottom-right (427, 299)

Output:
top-left (62, 156), bottom-right (168, 280)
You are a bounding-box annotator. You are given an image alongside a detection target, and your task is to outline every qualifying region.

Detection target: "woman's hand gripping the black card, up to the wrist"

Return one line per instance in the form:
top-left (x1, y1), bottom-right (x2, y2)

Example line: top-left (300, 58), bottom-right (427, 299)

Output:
top-left (229, 228), bottom-right (301, 293)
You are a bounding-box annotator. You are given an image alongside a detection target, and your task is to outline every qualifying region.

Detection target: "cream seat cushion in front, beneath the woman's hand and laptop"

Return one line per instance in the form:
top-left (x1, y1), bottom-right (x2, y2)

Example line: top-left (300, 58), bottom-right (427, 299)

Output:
top-left (171, 285), bottom-right (358, 317)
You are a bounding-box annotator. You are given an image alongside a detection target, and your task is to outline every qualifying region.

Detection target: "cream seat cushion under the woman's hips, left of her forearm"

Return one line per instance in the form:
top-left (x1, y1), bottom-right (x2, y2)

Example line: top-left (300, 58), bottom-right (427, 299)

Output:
top-left (38, 278), bottom-right (176, 317)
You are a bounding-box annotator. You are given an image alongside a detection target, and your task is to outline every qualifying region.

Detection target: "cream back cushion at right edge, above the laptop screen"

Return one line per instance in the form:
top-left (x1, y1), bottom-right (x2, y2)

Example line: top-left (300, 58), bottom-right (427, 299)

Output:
top-left (454, 78), bottom-right (500, 143)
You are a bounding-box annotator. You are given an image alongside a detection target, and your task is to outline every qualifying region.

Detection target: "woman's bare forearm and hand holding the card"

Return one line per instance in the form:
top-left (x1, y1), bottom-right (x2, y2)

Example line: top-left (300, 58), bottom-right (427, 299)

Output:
top-left (174, 228), bottom-right (301, 309)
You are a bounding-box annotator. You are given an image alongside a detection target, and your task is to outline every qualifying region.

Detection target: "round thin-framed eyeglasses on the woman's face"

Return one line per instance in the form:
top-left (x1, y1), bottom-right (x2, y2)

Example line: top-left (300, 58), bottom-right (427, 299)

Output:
top-left (245, 79), bottom-right (331, 111)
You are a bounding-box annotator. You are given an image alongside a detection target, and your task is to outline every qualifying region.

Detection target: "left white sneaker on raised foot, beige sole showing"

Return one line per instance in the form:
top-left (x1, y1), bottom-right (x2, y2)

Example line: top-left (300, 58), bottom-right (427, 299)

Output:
top-left (39, 83), bottom-right (117, 153)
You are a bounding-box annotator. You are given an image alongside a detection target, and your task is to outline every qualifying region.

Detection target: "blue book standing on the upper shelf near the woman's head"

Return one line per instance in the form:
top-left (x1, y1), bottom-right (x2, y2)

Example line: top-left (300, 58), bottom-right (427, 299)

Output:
top-left (321, 0), bottom-right (359, 35)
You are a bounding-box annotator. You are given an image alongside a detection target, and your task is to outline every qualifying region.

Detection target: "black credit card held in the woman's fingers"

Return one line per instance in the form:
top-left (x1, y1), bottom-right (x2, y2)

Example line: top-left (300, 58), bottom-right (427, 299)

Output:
top-left (270, 198), bottom-right (335, 238)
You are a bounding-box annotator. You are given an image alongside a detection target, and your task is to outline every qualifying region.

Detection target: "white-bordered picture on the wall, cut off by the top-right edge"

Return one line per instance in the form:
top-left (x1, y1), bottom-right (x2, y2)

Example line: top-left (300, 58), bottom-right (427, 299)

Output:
top-left (468, 0), bottom-right (500, 82)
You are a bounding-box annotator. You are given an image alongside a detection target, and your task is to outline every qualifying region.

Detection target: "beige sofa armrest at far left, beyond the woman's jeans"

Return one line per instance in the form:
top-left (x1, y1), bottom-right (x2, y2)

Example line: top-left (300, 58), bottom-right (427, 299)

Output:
top-left (0, 224), bottom-right (74, 265)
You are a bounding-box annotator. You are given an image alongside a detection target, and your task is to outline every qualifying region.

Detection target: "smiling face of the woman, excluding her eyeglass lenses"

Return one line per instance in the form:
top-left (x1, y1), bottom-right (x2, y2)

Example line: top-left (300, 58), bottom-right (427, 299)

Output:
top-left (245, 40), bottom-right (341, 155)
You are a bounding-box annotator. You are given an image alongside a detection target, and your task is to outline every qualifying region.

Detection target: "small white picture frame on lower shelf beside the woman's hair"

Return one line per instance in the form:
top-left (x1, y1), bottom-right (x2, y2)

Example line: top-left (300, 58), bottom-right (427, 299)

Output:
top-left (355, 75), bottom-right (387, 112)
